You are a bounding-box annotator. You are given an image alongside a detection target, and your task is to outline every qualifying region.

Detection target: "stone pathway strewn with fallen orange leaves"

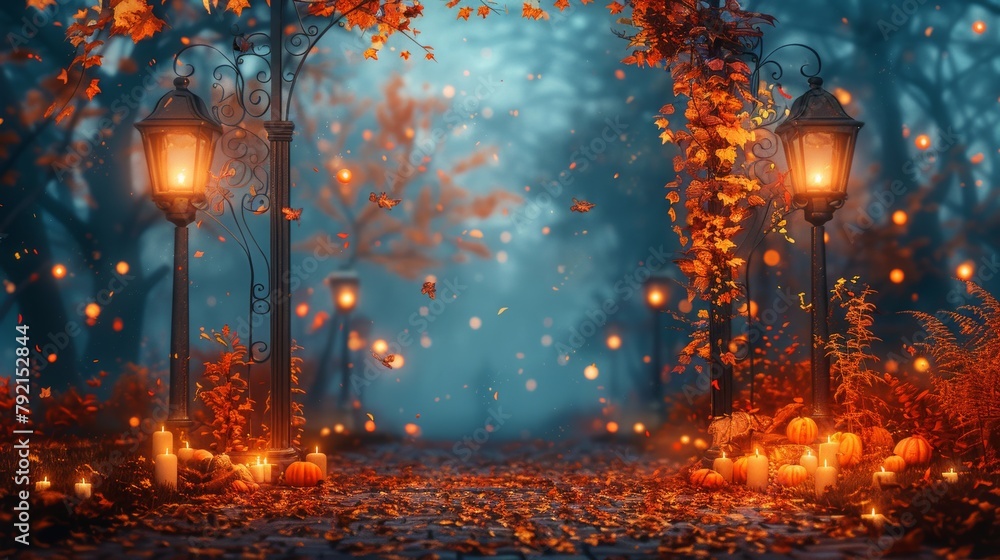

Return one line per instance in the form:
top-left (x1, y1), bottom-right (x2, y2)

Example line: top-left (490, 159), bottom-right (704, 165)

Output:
top-left (15, 444), bottom-right (932, 560)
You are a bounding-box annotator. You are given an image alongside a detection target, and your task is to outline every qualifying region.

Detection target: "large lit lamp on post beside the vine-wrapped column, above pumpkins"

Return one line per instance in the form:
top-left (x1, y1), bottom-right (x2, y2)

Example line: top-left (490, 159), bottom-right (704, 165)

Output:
top-left (775, 76), bottom-right (864, 424)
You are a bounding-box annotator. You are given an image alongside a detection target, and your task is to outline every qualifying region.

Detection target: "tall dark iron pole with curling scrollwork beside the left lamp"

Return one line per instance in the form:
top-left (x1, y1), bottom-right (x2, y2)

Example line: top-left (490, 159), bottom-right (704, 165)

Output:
top-left (141, 0), bottom-right (364, 472)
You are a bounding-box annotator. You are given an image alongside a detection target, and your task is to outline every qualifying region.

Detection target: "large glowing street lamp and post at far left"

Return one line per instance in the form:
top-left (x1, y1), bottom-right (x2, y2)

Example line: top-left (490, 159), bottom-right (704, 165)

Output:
top-left (135, 78), bottom-right (222, 430)
